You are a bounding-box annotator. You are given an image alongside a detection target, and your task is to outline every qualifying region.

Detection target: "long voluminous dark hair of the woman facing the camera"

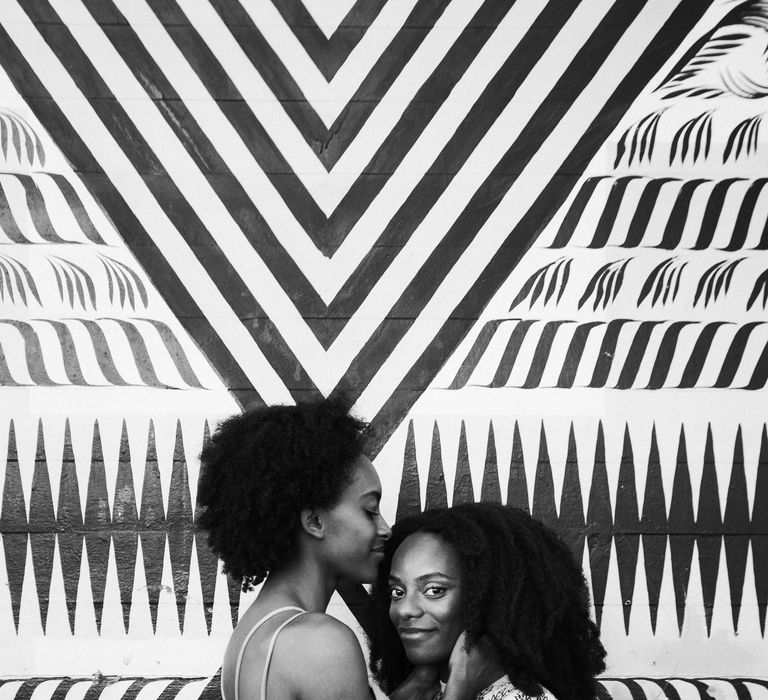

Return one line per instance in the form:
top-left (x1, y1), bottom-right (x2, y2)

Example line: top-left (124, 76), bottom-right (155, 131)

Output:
top-left (369, 503), bottom-right (605, 700)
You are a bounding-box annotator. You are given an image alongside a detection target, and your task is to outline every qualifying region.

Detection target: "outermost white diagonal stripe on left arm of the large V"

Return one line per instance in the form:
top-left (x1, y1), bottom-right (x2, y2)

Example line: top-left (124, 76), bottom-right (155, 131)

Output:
top-left (0, 2), bottom-right (293, 403)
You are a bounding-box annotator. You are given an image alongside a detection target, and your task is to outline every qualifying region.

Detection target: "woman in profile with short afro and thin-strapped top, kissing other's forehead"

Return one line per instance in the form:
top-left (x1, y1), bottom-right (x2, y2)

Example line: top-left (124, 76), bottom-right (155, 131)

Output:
top-left (197, 400), bottom-right (482, 700)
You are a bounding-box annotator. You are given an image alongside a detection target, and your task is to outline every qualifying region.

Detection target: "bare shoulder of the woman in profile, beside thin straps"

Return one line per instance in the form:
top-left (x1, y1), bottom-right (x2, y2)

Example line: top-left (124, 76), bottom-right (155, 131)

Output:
top-left (270, 613), bottom-right (370, 700)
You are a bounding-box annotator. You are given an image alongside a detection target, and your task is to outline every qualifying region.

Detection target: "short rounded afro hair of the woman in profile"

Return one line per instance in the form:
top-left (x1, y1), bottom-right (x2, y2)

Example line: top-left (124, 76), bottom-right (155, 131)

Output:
top-left (197, 399), bottom-right (367, 591)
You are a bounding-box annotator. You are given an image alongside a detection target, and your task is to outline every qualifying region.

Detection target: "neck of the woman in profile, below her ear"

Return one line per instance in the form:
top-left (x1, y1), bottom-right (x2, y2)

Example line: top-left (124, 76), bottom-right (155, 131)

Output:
top-left (259, 557), bottom-right (338, 612)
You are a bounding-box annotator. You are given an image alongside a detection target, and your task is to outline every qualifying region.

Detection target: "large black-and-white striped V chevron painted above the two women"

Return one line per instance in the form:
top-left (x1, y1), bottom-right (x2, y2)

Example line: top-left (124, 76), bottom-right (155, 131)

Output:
top-left (0, 0), bottom-right (706, 416)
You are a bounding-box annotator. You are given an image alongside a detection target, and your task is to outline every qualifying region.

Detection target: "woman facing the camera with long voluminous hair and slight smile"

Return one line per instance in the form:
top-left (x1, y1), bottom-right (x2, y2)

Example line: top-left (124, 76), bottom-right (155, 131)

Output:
top-left (370, 503), bottom-right (605, 700)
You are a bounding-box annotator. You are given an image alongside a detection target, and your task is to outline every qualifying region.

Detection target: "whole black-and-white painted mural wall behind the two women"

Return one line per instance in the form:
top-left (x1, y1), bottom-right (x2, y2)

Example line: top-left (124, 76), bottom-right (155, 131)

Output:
top-left (0, 0), bottom-right (768, 700)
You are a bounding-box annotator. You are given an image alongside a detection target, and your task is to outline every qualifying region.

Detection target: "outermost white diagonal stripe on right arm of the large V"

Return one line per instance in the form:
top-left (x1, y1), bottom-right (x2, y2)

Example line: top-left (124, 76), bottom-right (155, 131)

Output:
top-left (354, 0), bottom-right (676, 416)
